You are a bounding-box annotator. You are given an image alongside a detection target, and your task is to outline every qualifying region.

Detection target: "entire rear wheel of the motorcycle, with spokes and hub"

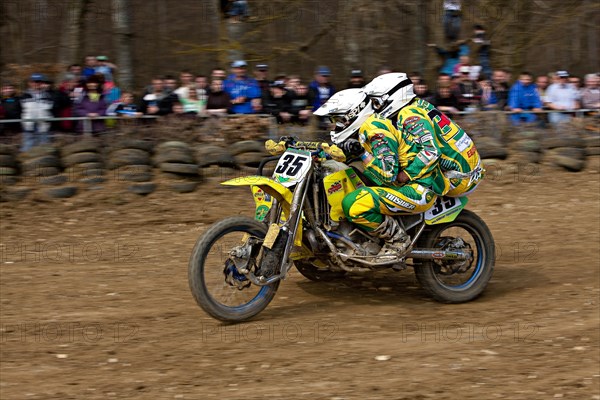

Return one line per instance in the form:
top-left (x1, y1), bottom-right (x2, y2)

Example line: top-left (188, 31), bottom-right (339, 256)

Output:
top-left (415, 210), bottom-right (496, 303)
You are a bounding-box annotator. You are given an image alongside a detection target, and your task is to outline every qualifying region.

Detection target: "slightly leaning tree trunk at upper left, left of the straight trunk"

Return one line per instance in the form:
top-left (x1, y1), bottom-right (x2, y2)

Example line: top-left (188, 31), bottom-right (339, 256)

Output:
top-left (58, 0), bottom-right (87, 65)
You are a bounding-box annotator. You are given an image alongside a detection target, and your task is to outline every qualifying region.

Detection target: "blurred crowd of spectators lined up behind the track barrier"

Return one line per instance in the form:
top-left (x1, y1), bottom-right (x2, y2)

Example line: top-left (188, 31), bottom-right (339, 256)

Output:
top-left (0, 32), bottom-right (600, 151)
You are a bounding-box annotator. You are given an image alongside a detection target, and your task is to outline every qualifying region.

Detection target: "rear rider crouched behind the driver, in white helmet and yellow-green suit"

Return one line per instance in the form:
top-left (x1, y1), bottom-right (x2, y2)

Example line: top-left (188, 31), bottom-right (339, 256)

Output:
top-left (363, 73), bottom-right (484, 197)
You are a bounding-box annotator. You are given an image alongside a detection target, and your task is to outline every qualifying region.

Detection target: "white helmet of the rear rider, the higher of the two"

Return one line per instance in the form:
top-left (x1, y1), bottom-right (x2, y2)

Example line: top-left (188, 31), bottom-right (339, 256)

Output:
top-left (363, 72), bottom-right (416, 118)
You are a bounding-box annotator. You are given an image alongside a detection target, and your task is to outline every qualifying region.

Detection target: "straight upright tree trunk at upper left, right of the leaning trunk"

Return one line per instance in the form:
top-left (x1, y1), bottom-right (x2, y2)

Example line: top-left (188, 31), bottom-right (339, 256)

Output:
top-left (112, 0), bottom-right (134, 90)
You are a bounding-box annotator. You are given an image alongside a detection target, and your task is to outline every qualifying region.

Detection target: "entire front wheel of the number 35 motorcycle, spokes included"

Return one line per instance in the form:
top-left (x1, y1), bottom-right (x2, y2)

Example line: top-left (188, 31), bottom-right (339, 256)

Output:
top-left (188, 216), bottom-right (279, 322)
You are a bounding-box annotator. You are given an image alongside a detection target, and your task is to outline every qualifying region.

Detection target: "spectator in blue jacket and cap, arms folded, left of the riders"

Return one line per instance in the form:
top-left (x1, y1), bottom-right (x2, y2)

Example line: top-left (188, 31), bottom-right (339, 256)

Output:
top-left (223, 60), bottom-right (261, 114)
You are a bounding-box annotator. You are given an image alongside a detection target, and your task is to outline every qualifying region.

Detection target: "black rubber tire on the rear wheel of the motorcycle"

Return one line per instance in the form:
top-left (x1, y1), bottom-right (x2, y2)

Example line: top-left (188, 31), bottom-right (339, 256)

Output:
top-left (415, 210), bottom-right (496, 303)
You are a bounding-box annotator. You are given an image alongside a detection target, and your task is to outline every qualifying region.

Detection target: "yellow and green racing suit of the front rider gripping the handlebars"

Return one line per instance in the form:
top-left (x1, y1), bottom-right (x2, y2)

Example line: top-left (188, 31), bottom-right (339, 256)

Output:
top-left (342, 114), bottom-right (450, 231)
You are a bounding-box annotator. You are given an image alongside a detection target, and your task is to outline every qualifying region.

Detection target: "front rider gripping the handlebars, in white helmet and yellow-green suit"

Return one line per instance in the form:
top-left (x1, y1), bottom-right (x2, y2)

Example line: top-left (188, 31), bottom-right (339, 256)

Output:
top-left (315, 87), bottom-right (450, 255)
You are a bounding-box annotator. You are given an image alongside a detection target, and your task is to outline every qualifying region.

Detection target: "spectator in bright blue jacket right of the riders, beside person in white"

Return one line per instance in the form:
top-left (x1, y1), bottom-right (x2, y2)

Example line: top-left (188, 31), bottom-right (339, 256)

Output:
top-left (508, 72), bottom-right (542, 125)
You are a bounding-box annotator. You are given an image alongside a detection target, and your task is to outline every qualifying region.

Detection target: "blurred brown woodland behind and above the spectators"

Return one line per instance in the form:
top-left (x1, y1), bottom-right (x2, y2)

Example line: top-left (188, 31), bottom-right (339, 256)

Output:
top-left (0, 0), bottom-right (600, 89)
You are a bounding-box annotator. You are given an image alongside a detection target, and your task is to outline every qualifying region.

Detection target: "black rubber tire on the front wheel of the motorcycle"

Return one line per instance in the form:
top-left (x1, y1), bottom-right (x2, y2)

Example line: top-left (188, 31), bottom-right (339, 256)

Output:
top-left (188, 216), bottom-right (280, 322)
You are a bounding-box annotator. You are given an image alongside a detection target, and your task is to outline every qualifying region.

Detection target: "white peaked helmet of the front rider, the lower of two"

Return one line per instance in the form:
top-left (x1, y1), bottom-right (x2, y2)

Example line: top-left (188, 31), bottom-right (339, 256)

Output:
top-left (314, 88), bottom-right (374, 144)
